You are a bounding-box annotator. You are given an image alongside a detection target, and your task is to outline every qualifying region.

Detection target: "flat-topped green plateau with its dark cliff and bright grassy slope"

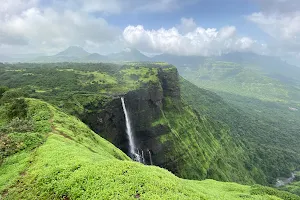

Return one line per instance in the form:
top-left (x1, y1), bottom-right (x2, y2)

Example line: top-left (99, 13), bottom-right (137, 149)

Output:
top-left (1, 63), bottom-right (255, 183)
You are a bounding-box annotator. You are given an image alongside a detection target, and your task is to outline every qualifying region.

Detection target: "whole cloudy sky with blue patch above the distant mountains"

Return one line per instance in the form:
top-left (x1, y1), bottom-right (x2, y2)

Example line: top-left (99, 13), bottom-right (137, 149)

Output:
top-left (0, 0), bottom-right (300, 63)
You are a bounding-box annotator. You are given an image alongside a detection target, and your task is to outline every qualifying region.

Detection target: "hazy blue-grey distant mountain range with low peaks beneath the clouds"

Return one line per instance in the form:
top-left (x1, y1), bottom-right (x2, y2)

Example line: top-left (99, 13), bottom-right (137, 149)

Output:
top-left (0, 46), bottom-right (300, 75)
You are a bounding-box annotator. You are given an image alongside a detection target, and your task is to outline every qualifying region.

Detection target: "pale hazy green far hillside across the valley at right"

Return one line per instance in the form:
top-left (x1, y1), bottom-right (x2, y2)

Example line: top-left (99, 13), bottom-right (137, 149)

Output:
top-left (181, 60), bottom-right (300, 103)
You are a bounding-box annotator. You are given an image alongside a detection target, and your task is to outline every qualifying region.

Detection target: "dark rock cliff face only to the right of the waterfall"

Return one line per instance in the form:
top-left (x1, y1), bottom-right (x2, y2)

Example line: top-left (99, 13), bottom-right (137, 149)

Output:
top-left (125, 68), bottom-right (180, 166)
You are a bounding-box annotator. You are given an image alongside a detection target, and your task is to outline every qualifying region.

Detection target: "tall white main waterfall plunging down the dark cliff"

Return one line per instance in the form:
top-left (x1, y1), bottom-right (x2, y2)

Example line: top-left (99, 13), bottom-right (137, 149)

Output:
top-left (121, 97), bottom-right (142, 162)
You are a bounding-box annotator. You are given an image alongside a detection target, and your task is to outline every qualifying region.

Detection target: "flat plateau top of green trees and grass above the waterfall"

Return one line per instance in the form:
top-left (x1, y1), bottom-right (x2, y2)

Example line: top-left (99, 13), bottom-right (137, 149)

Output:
top-left (0, 63), bottom-right (170, 115)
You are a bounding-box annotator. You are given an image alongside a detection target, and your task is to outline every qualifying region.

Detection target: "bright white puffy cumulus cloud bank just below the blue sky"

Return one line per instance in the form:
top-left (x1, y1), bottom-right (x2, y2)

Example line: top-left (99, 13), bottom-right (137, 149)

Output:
top-left (123, 22), bottom-right (258, 56)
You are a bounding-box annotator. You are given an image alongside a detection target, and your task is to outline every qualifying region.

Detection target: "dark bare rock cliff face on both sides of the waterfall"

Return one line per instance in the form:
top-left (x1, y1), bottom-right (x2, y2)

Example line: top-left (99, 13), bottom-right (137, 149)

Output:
top-left (82, 67), bottom-right (180, 166)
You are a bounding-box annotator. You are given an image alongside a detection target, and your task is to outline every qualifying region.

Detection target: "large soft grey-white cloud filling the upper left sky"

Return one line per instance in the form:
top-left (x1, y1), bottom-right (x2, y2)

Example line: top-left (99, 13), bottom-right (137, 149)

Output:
top-left (0, 0), bottom-right (121, 53)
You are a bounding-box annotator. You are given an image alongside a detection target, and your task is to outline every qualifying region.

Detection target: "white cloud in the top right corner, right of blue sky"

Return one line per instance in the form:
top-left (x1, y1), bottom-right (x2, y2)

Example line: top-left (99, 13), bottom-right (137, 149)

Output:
top-left (247, 0), bottom-right (300, 62)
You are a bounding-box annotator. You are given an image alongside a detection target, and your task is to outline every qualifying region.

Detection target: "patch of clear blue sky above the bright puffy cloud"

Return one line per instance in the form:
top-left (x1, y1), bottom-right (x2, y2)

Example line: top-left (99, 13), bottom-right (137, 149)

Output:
top-left (107, 0), bottom-right (259, 29)
